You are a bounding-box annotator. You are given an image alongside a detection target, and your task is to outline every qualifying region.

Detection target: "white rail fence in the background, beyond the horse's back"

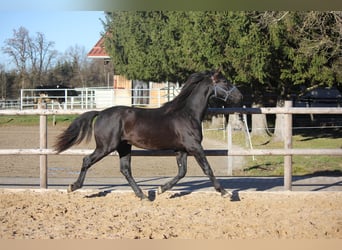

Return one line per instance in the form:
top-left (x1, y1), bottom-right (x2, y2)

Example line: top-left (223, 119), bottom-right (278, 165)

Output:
top-left (18, 87), bottom-right (180, 110)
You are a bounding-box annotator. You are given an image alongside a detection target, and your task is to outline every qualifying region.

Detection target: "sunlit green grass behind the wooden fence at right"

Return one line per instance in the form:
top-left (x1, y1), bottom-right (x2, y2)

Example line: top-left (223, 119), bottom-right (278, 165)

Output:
top-left (204, 126), bottom-right (342, 176)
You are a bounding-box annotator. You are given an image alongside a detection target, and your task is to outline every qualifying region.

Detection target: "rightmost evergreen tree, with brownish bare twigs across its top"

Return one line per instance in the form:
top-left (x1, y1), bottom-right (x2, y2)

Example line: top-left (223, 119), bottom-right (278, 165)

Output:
top-left (264, 12), bottom-right (342, 140)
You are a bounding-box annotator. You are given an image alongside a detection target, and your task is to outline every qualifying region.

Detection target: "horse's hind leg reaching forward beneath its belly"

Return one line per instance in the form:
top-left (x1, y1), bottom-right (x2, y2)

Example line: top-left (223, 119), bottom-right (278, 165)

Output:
top-left (117, 143), bottom-right (147, 199)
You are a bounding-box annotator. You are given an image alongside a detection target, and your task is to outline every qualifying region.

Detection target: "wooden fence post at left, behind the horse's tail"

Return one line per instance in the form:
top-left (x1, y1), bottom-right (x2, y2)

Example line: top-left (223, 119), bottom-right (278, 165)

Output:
top-left (39, 102), bottom-right (48, 188)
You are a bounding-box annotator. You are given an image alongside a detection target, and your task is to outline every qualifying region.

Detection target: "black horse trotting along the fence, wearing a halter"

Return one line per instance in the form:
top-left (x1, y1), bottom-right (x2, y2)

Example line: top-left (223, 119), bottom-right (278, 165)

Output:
top-left (55, 71), bottom-right (242, 199)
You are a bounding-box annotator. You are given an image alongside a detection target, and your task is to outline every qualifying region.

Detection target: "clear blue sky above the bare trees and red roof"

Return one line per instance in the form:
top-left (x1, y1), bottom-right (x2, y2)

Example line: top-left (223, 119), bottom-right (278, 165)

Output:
top-left (0, 10), bottom-right (105, 69)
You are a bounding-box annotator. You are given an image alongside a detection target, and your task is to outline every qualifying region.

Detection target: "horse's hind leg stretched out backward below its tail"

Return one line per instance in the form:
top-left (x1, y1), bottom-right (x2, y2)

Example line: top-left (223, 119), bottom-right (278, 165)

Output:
top-left (68, 148), bottom-right (110, 192)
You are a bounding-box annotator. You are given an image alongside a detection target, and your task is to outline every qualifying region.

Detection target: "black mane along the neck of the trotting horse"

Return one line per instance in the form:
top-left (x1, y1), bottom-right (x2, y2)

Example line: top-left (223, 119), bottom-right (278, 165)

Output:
top-left (162, 71), bottom-right (212, 113)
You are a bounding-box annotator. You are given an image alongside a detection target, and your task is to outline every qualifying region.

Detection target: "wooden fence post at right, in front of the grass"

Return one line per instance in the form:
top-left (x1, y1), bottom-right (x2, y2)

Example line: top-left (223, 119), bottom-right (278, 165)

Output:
top-left (284, 101), bottom-right (292, 191)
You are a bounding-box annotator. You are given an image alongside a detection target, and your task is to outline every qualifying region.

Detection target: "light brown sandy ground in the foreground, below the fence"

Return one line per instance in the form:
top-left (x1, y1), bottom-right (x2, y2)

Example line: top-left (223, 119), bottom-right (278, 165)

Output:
top-left (0, 189), bottom-right (342, 239)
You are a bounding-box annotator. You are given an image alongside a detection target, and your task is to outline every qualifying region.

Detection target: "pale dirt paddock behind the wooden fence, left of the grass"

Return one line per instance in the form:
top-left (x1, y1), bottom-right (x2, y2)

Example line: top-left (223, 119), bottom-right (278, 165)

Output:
top-left (0, 126), bottom-right (243, 178)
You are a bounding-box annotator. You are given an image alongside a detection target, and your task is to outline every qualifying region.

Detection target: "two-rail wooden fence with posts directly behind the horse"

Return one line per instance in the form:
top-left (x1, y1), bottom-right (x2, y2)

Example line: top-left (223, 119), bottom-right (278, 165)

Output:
top-left (0, 101), bottom-right (342, 190)
